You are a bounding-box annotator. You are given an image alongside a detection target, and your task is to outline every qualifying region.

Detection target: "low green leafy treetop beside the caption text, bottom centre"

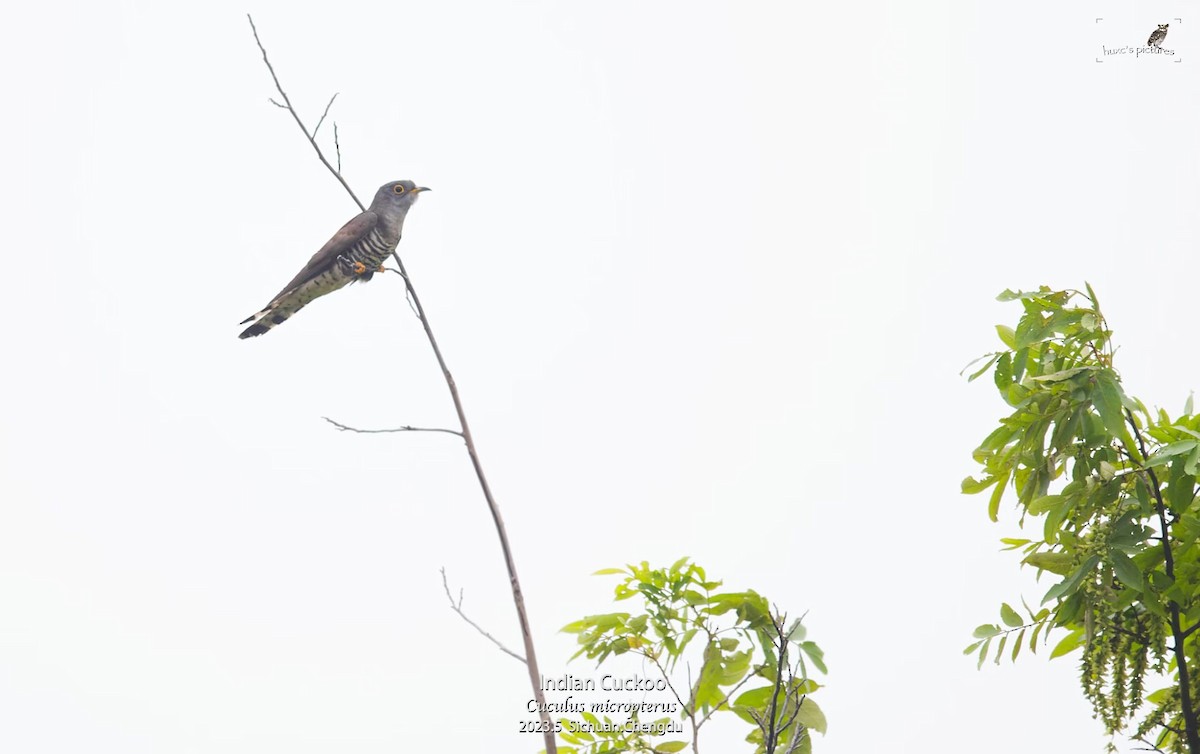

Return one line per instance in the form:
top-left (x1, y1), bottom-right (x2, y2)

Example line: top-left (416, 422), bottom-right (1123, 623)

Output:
top-left (559, 557), bottom-right (826, 754)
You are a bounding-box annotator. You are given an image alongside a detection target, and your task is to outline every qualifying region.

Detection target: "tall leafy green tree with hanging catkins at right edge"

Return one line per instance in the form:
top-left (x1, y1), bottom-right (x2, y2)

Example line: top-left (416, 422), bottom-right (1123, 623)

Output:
top-left (962, 286), bottom-right (1200, 754)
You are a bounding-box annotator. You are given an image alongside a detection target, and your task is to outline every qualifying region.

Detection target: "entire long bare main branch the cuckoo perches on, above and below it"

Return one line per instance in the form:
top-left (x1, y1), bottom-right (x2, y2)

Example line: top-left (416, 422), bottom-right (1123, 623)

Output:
top-left (246, 13), bottom-right (558, 754)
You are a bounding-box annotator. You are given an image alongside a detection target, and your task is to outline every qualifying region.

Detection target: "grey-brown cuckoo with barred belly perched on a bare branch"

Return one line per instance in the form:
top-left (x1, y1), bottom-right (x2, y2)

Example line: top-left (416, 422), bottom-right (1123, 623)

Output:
top-left (238, 180), bottom-right (428, 339)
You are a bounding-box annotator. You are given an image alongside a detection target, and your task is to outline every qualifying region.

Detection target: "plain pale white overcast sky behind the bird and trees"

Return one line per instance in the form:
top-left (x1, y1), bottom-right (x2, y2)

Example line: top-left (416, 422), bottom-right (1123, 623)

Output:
top-left (0, 0), bottom-right (1200, 754)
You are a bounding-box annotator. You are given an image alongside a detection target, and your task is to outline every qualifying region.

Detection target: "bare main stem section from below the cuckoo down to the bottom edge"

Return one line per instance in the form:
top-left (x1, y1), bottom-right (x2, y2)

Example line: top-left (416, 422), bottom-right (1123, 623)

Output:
top-left (391, 251), bottom-right (558, 754)
